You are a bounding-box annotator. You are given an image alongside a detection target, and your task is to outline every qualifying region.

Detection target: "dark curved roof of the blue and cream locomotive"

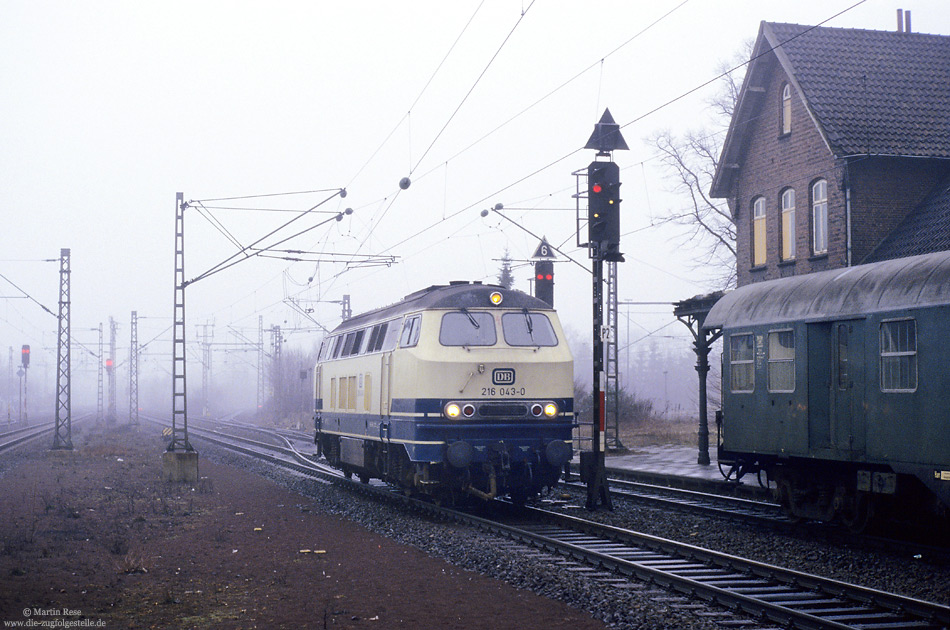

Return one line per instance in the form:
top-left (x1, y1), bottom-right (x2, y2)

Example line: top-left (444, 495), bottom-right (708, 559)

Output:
top-left (333, 281), bottom-right (551, 332)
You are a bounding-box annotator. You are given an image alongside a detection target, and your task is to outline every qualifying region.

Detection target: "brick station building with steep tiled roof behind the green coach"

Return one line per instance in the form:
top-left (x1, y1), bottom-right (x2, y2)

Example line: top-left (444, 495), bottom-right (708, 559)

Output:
top-left (711, 12), bottom-right (950, 286)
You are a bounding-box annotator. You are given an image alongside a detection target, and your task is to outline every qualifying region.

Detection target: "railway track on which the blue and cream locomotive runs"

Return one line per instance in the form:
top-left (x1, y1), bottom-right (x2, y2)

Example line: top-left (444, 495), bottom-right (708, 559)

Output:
top-left (150, 419), bottom-right (950, 630)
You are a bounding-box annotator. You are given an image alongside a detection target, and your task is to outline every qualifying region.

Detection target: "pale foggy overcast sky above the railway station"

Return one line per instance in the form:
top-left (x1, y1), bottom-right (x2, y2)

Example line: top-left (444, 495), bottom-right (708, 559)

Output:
top-left (0, 0), bottom-right (950, 410)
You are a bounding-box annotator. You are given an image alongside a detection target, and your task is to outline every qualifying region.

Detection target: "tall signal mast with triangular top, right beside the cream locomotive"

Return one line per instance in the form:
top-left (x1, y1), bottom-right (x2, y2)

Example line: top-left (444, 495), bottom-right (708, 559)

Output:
top-left (581, 109), bottom-right (629, 510)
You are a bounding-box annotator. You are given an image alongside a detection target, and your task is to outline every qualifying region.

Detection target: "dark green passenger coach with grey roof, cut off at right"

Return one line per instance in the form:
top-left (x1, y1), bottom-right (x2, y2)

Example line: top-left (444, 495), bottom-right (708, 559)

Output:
top-left (704, 252), bottom-right (950, 530)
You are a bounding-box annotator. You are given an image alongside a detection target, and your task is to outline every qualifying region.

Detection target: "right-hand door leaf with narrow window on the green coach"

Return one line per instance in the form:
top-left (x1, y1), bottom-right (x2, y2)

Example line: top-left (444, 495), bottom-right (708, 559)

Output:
top-left (831, 320), bottom-right (865, 455)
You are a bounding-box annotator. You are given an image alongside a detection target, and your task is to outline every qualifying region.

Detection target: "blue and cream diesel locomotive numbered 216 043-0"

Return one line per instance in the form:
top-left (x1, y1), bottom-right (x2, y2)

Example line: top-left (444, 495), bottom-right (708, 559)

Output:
top-left (314, 282), bottom-right (574, 501)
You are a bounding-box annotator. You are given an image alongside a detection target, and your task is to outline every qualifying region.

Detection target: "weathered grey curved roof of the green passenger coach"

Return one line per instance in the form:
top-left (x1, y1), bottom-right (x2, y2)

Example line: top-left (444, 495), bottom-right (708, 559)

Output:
top-left (703, 251), bottom-right (950, 329)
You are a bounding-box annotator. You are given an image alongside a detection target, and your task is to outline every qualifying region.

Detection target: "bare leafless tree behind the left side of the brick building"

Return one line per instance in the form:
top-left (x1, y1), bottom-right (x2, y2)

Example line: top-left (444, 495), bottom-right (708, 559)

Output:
top-left (645, 41), bottom-right (753, 289)
